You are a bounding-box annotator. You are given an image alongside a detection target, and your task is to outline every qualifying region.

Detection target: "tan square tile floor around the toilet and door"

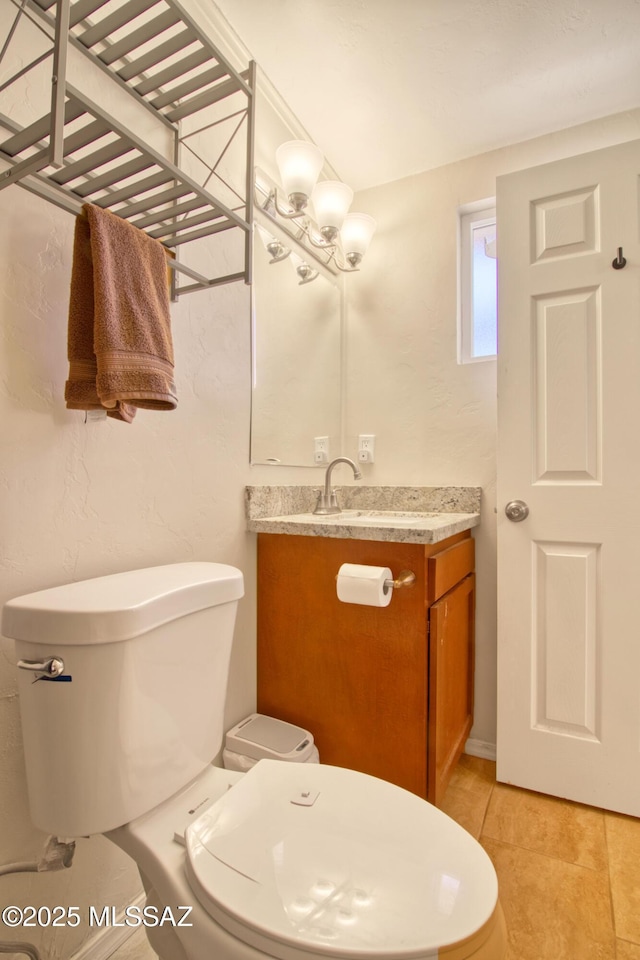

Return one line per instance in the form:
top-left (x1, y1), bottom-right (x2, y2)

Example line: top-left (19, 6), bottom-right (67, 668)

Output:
top-left (111, 756), bottom-right (640, 960)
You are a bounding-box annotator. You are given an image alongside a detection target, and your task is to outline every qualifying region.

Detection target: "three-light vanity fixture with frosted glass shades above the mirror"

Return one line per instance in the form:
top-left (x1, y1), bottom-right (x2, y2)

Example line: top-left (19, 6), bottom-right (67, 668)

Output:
top-left (256, 140), bottom-right (376, 273)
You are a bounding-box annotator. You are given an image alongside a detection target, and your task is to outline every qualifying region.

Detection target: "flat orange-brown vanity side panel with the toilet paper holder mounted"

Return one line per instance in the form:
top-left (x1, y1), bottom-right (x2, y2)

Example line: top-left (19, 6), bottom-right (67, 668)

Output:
top-left (258, 534), bottom-right (427, 797)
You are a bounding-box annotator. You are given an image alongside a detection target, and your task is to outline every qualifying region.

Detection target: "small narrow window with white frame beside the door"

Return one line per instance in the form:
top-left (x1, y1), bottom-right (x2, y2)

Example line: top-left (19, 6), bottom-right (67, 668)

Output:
top-left (458, 200), bottom-right (498, 363)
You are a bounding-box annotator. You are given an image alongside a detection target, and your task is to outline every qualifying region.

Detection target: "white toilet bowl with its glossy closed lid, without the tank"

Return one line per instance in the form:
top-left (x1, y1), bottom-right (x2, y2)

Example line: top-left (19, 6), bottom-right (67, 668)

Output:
top-left (107, 760), bottom-right (506, 960)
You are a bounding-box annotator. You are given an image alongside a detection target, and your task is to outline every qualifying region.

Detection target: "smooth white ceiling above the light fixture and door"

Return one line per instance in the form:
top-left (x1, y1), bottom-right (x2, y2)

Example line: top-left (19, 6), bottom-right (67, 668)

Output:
top-left (211, 0), bottom-right (640, 189)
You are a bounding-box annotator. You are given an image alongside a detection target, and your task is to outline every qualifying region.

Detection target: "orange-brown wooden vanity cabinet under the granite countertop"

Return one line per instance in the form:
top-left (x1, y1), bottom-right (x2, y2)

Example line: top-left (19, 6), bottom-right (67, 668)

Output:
top-left (258, 531), bottom-right (475, 804)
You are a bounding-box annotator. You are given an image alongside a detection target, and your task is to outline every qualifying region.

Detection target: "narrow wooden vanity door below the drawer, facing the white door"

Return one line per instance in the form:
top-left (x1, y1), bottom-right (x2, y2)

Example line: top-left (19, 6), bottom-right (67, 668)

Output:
top-left (429, 574), bottom-right (475, 805)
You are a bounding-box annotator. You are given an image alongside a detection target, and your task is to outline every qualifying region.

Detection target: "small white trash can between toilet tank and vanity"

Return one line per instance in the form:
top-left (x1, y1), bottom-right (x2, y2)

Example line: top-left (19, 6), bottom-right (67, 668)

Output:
top-left (222, 713), bottom-right (320, 772)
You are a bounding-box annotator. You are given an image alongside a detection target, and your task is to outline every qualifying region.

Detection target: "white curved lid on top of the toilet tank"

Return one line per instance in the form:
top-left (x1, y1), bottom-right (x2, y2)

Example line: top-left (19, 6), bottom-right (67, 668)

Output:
top-left (0, 562), bottom-right (244, 645)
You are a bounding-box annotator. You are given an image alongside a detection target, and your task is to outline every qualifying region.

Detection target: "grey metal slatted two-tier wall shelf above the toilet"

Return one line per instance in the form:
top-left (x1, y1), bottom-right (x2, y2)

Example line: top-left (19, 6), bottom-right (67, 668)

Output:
top-left (0, 0), bottom-right (255, 295)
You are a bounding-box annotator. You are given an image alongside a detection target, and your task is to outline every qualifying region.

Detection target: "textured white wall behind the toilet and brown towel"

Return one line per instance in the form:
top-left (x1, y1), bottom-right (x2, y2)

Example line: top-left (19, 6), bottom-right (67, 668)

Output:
top-left (0, 187), bottom-right (242, 958)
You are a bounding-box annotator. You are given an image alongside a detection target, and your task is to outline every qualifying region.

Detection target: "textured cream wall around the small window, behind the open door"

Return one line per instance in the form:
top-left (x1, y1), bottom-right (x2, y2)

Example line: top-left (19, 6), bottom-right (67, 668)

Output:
top-left (347, 111), bottom-right (640, 743)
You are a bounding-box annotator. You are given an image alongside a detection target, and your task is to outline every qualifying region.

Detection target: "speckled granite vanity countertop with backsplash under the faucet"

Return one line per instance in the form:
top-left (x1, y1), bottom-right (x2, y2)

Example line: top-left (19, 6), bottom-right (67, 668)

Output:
top-left (245, 486), bottom-right (481, 543)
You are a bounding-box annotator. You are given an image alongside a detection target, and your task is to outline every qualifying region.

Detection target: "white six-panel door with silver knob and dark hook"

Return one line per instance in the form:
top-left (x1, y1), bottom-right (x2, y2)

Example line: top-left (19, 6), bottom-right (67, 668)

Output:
top-left (497, 135), bottom-right (640, 816)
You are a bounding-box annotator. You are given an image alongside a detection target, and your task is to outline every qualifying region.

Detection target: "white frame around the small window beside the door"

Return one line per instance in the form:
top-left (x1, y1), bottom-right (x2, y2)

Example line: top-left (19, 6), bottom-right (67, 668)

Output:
top-left (458, 197), bottom-right (498, 364)
